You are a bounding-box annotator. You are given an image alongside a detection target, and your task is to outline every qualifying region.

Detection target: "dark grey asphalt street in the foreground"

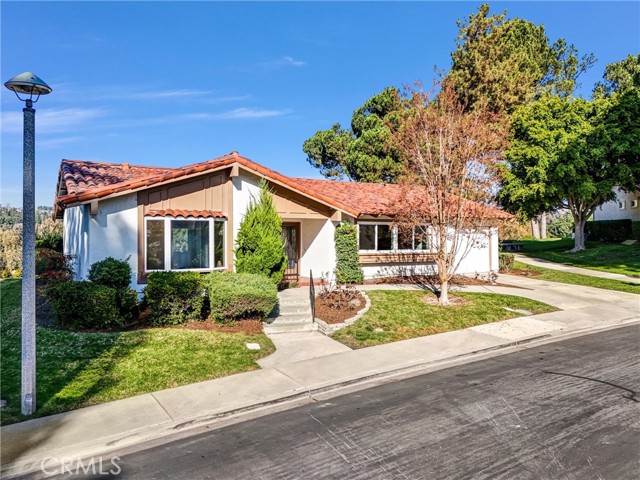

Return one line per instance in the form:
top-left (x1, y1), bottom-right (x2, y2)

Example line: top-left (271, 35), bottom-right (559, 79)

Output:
top-left (40, 326), bottom-right (640, 480)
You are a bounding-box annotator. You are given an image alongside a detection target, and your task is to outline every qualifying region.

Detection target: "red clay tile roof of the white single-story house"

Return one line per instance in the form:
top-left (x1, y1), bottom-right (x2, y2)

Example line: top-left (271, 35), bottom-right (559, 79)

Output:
top-left (54, 152), bottom-right (510, 218)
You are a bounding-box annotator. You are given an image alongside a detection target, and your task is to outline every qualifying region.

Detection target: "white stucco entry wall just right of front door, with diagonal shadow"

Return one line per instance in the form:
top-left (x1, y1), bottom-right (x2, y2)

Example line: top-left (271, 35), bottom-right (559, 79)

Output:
top-left (300, 219), bottom-right (336, 278)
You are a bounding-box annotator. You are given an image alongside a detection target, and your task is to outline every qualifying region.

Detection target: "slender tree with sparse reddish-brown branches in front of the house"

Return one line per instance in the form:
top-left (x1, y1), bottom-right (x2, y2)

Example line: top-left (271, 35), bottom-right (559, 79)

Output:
top-left (394, 79), bottom-right (508, 305)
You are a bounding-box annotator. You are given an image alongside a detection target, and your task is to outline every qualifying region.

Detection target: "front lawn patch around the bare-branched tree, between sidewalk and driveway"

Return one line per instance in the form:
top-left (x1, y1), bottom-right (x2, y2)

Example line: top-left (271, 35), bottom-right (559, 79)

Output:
top-left (332, 290), bottom-right (557, 348)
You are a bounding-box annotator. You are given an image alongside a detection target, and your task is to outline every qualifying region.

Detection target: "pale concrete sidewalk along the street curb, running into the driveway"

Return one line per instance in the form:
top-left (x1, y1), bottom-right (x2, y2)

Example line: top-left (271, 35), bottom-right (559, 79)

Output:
top-left (0, 276), bottom-right (640, 478)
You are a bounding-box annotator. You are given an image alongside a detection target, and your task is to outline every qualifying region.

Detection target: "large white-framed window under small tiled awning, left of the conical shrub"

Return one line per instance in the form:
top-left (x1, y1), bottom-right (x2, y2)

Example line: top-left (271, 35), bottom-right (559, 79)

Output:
top-left (145, 217), bottom-right (226, 271)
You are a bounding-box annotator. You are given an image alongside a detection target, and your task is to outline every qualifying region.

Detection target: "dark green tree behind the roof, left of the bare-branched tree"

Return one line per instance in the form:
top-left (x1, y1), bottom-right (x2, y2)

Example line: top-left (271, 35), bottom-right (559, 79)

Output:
top-left (302, 87), bottom-right (403, 182)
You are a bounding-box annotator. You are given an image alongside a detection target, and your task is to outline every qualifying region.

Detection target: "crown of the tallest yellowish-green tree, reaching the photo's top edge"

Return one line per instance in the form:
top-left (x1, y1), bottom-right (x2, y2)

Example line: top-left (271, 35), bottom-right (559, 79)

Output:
top-left (449, 4), bottom-right (595, 114)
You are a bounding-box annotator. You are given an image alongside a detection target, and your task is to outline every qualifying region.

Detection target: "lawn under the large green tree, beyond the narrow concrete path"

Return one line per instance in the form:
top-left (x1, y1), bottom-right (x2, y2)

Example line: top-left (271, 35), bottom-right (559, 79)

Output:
top-left (521, 238), bottom-right (640, 277)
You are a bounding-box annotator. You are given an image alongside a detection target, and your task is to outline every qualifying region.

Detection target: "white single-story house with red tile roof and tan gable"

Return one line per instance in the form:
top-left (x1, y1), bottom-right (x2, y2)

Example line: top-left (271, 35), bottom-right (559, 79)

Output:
top-left (54, 152), bottom-right (509, 289)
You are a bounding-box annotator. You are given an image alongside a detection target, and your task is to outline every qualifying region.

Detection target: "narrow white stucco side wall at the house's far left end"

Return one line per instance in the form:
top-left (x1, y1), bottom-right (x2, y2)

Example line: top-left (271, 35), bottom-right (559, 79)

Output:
top-left (62, 205), bottom-right (89, 280)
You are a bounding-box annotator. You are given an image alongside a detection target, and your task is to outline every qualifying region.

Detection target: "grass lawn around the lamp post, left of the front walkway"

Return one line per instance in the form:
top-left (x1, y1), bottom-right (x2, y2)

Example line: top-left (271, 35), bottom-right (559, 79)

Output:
top-left (0, 279), bottom-right (275, 425)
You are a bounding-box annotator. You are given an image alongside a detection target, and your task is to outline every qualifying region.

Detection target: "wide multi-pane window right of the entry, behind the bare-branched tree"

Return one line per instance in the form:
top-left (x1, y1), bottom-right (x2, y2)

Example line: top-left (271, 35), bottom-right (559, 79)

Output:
top-left (358, 223), bottom-right (431, 251)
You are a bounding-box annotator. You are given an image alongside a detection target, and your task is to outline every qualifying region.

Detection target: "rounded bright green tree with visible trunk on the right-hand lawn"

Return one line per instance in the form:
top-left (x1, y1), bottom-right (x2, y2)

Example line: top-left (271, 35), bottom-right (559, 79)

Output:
top-left (499, 89), bottom-right (640, 251)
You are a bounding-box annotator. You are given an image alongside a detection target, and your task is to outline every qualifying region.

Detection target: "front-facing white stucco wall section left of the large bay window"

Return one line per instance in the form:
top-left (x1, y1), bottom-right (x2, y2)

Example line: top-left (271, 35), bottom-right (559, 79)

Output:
top-left (81, 193), bottom-right (139, 290)
